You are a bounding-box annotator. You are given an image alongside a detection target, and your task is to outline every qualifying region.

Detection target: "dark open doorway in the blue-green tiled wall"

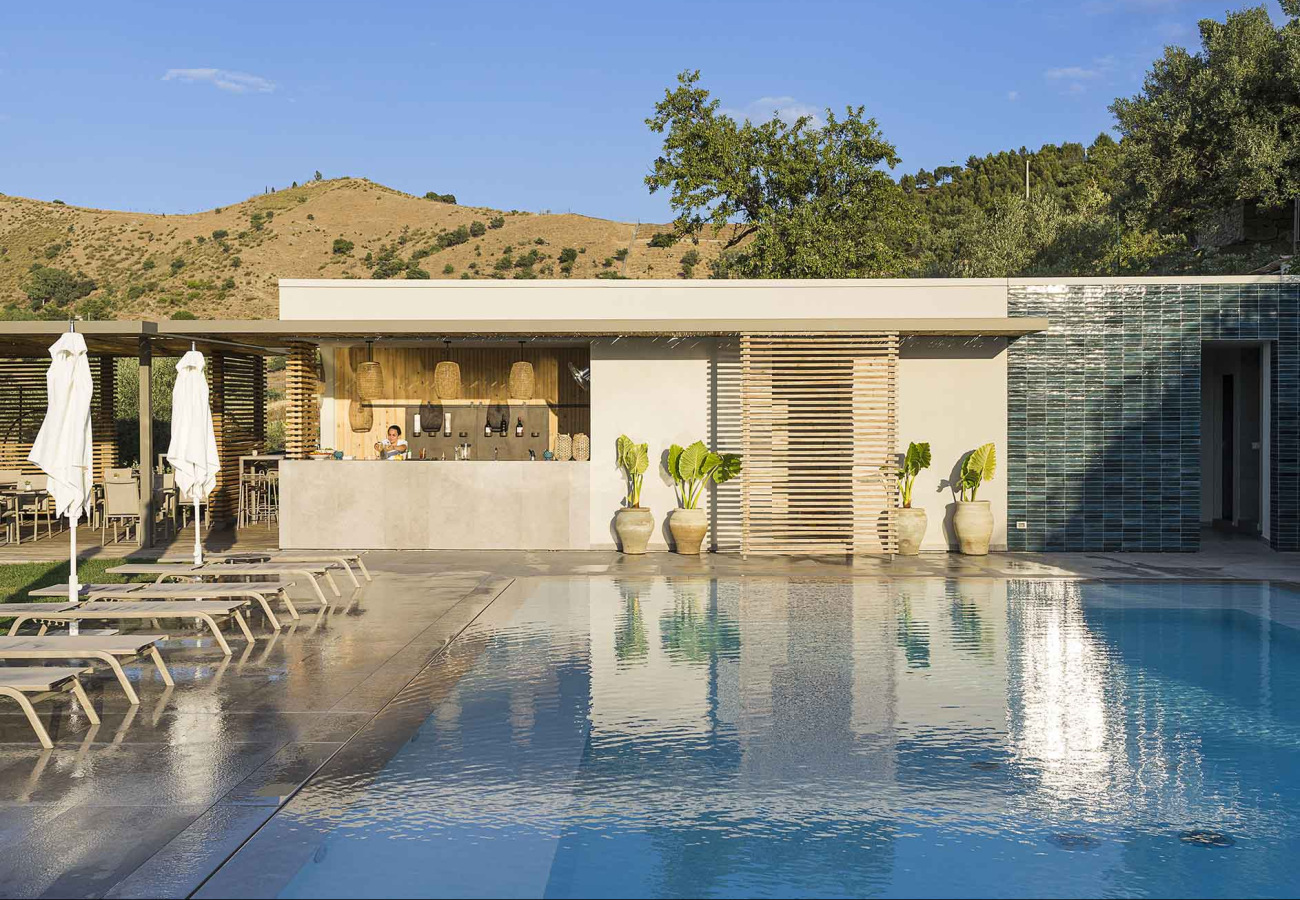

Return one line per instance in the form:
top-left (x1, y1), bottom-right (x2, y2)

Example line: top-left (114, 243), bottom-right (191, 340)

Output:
top-left (1201, 342), bottom-right (1269, 535)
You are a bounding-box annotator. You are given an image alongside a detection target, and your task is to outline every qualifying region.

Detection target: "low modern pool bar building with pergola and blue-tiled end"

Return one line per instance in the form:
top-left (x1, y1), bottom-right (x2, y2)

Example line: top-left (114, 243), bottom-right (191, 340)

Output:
top-left (0, 276), bottom-right (1300, 554)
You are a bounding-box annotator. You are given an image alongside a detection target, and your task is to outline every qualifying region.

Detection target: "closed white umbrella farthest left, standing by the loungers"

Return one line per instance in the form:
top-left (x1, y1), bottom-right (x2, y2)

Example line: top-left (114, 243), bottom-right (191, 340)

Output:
top-left (27, 332), bottom-right (95, 611)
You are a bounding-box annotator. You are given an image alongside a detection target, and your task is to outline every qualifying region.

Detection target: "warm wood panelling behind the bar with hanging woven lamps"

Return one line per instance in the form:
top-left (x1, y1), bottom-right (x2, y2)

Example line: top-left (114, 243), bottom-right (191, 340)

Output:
top-left (333, 345), bottom-right (592, 458)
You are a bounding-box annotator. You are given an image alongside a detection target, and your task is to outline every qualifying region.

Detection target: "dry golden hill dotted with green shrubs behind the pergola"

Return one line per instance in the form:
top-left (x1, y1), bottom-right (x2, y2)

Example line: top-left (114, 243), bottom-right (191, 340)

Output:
top-left (0, 178), bottom-right (727, 319)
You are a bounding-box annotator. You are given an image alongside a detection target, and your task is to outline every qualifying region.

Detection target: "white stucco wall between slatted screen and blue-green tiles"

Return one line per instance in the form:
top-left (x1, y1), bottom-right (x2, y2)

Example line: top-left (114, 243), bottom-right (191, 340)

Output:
top-left (898, 338), bottom-right (1008, 550)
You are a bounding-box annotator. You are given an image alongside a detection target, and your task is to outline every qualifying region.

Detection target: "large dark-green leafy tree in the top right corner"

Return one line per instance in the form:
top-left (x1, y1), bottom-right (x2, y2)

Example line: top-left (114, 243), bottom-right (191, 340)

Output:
top-left (1110, 0), bottom-right (1300, 235)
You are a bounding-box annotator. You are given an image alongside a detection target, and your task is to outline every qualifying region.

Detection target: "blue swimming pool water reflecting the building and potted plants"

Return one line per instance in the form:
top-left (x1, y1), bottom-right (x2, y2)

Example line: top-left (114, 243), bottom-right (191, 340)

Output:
top-left (266, 579), bottom-right (1300, 897)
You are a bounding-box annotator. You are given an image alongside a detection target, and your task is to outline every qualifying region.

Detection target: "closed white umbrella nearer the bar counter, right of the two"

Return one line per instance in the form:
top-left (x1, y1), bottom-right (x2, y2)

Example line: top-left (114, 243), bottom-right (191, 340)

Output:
top-left (166, 350), bottom-right (221, 566)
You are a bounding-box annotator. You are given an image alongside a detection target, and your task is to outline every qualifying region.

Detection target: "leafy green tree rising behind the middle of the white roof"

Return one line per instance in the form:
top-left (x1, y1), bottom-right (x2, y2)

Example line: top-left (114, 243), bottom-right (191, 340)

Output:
top-left (646, 72), bottom-right (917, 278)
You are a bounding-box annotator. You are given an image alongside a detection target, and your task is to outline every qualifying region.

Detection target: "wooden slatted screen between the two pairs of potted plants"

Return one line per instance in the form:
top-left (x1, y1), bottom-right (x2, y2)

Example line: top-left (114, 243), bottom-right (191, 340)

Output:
top-left (740, 332), bottom-right (898, 553)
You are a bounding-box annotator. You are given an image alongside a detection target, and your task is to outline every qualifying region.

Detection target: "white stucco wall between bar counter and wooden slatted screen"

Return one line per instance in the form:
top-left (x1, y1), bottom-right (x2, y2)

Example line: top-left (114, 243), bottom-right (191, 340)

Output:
top-left (590, 338), bottom-right (714, 550)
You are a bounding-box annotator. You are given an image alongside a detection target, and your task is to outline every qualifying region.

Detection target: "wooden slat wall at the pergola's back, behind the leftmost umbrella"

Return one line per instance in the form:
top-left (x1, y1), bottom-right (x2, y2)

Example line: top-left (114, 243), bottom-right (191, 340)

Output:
top-left (0, 356), bottom-right (118, 481)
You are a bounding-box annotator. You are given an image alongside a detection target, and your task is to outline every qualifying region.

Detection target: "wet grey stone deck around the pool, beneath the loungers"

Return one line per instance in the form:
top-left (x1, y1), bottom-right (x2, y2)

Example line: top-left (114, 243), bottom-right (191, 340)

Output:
top-left (0, 540), bottom-right (1300, 897)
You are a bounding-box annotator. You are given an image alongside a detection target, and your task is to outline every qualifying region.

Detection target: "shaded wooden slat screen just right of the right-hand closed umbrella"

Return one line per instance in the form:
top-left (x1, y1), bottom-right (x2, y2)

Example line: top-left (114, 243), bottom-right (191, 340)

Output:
top-left (208, 354), bottom-right (267, 522)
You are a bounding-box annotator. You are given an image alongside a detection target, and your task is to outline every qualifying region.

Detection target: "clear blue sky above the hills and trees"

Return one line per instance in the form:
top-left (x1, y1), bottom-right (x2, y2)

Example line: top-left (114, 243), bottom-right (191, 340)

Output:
top-left (0, 0), bottom-right (1281, 221)
